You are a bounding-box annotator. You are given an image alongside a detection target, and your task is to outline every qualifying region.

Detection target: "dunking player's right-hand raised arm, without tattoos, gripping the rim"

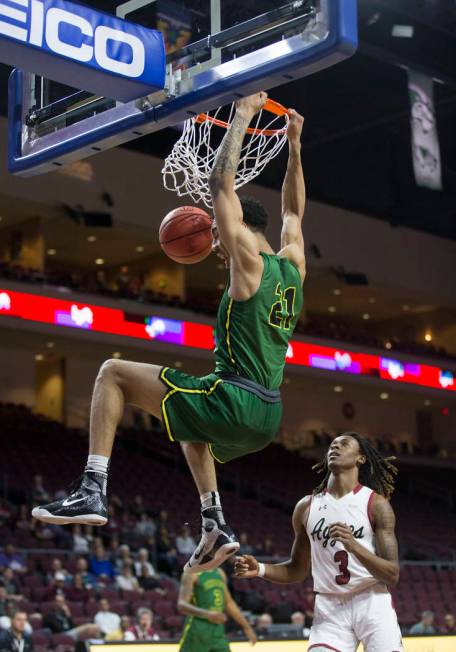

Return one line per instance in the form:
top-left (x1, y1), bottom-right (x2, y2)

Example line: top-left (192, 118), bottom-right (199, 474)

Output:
top-left (281, 109), bottom-right (306, 281)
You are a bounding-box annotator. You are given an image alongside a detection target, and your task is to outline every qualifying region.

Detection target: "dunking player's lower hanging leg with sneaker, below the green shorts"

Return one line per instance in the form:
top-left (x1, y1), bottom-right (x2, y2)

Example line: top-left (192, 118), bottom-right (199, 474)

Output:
top-left (181, 442), bottom-right (239, 573)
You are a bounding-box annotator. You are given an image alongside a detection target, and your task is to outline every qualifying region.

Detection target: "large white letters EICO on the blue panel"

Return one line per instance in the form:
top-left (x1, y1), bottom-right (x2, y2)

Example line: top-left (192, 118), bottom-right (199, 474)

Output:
top-left (0, 0), bottom-right (146, 78)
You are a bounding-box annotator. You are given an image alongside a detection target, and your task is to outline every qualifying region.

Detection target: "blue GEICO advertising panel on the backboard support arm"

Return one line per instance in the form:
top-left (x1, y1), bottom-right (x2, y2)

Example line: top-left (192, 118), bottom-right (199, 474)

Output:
top-left (0, 0), bottom-right (166, 102)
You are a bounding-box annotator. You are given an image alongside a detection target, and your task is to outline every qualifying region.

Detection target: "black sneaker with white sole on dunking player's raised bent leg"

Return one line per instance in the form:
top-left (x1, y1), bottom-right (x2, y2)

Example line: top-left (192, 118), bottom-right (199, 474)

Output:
top-left (32, 469), bottom-right (108, 525)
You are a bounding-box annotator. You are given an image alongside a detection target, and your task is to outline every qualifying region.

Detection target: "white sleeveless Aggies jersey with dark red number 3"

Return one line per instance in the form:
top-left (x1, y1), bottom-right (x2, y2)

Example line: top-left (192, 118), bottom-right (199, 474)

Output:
top-left (305, 484), bottom-right (378, 595)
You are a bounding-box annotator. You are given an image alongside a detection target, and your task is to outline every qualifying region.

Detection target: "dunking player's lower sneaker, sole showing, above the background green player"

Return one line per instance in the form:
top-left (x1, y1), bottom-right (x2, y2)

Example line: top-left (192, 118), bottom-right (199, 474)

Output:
top-left (184, 516), bottom-right (240, 573)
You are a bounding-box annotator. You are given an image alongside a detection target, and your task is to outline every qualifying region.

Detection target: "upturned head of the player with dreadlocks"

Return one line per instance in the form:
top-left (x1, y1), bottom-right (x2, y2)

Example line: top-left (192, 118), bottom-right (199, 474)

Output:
top-left (313, 432), bottom-right (397, 498)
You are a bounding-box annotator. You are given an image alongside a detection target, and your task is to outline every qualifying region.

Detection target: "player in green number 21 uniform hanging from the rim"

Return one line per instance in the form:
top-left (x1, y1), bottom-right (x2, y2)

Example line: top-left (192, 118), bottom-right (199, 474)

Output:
top-left (32, 93), bottom-right (305, 572)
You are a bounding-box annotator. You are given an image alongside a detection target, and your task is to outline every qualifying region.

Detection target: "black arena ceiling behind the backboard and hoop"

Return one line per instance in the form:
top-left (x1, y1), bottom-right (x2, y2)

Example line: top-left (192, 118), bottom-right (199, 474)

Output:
top-left (0, 0), bottom-right (456, 239)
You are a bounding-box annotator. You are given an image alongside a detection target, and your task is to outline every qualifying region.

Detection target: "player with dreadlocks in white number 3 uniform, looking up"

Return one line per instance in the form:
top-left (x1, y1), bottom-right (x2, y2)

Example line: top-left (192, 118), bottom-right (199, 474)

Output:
top-left (236, 432), bottom-right (403, 652)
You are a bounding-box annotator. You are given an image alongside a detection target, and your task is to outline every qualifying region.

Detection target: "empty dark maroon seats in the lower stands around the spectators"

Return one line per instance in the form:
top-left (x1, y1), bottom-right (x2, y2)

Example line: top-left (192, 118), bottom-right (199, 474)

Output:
top-left (0, 404), bottom-right (456, 640)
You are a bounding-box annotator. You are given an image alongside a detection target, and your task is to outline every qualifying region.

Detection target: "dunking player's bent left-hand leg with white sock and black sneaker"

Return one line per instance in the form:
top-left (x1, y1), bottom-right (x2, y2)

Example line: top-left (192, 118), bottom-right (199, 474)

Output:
top-left (32, 360), bottom-right (167, 525)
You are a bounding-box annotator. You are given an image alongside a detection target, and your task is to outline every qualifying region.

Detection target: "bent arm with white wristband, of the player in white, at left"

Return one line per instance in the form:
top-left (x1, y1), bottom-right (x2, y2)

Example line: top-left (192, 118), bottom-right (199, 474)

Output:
top-left (235, 496), bottom-right (310, 584)
